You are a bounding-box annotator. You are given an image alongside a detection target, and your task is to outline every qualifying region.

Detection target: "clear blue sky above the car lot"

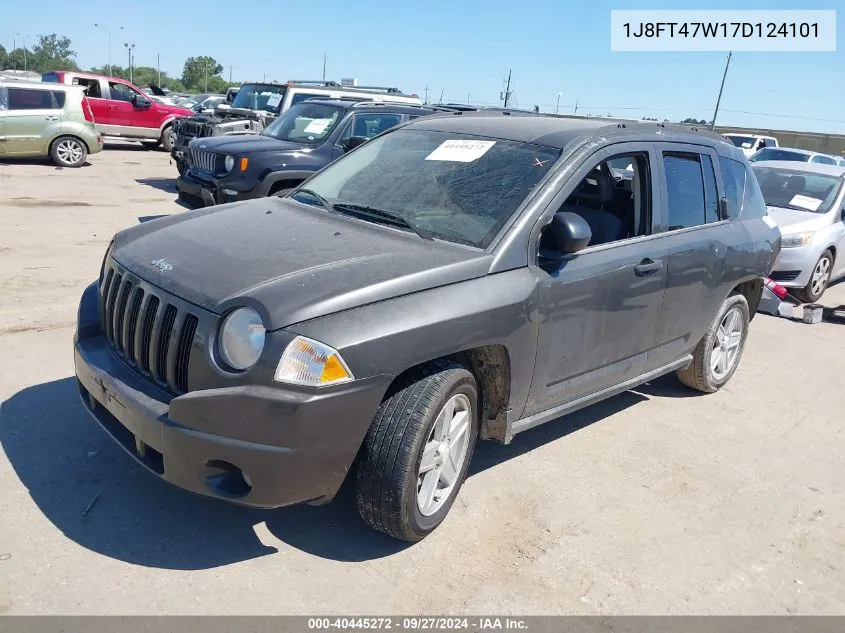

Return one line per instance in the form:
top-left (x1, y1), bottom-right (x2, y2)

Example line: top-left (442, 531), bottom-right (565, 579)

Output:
top-left (6, 0), bottom-right (845, 134)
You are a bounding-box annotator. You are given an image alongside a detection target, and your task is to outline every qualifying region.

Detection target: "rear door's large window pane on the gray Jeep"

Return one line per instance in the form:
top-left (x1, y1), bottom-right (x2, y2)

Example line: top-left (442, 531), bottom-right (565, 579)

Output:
top-left (663, 154), bottom-right (712, 231)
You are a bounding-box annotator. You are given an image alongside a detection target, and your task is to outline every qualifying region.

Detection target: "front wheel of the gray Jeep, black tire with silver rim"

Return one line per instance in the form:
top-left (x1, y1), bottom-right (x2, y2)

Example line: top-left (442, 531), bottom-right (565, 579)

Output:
top-left (356, 361), bottom-right (479, 542)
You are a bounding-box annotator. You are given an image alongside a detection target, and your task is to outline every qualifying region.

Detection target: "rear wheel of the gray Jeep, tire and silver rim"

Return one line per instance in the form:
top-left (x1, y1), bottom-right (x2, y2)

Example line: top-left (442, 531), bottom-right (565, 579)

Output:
top-left (677, 294), bottom-right (751, 393)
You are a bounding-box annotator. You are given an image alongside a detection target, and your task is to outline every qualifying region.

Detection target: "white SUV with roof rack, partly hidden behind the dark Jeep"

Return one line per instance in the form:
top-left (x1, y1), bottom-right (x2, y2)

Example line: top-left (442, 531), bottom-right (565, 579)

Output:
top-left (171, 81), bottom-right (422, 174)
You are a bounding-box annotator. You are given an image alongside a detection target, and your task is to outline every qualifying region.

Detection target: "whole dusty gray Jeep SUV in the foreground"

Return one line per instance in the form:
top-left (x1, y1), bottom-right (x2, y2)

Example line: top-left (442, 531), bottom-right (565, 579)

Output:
top-left (74, 112), bottom-right (780, 541)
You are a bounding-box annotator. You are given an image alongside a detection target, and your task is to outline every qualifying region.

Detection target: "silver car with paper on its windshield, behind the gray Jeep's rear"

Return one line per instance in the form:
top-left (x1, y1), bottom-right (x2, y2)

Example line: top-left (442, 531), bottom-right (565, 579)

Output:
top-left (753, 161), bottom-right (845, 303)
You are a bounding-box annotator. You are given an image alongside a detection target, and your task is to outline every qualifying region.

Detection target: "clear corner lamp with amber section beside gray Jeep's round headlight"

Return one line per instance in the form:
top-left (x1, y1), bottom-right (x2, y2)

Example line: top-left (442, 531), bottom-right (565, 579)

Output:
top-left (275, 336), bottom-right (354, 386)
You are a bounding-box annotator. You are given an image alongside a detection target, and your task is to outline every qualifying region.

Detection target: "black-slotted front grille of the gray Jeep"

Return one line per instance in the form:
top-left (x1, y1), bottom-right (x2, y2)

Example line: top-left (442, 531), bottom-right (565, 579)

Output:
top-left (100, 267), bottom-right (199, 393)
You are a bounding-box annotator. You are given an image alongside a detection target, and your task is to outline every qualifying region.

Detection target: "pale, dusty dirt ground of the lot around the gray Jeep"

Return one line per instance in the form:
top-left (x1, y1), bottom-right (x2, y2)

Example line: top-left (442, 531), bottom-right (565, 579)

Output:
top-left (0, 144), bottom-right (845, 614)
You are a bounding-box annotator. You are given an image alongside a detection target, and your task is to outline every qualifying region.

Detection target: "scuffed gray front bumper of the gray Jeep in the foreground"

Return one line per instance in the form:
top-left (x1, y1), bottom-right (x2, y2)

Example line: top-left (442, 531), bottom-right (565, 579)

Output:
top-left (74, 284), bottom-right (387, 508)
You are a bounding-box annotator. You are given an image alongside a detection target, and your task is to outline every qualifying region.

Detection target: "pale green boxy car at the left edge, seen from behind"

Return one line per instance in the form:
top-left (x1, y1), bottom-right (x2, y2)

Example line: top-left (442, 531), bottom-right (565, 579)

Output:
top-left (0, 79), bottom-right (103, 167)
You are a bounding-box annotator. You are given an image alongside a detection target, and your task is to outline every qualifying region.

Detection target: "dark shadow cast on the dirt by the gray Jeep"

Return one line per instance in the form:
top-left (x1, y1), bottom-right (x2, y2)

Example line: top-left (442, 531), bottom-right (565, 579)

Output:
top-left (0, 378), bottom-right (684, 569)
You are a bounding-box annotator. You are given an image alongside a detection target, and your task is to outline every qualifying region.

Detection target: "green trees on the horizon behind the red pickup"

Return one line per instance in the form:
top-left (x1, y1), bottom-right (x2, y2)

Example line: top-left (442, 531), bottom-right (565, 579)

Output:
top-left (0, 33), bottom-right (238, 93)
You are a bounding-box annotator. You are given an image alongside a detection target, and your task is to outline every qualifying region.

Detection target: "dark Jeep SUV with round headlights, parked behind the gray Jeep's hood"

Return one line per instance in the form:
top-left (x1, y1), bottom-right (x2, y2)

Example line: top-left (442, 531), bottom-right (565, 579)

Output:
top-left (176, 99), bottom-right (434, 205)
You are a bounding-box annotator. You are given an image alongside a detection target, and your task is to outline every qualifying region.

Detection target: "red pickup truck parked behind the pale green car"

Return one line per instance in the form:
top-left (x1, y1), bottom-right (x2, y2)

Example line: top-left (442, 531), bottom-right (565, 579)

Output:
top-left (41, 70), bottom-right (194, 152)
